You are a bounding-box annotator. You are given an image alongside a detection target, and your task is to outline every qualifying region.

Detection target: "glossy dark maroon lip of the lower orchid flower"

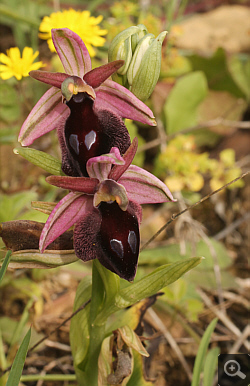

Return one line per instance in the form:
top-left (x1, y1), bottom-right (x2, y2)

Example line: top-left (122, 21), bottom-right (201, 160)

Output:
top-left (98, 202), bottom-right (140, 281)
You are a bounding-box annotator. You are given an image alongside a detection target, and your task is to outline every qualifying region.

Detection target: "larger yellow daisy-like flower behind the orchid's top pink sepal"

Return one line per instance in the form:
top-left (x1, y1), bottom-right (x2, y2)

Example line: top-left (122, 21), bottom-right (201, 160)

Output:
top-left (39, 9), bottom-right (107, 57)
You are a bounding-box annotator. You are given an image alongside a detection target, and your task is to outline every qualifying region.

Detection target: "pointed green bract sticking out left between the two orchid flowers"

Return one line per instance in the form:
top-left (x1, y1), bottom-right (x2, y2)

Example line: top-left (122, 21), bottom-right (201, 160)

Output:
top-left (13, 147), bottom-right (64, 176)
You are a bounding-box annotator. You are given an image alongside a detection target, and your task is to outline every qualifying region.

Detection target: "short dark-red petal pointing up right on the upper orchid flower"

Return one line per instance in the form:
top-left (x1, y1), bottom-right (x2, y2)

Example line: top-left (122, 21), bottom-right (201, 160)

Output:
top-left (83, 60), bottom-right (124, 88)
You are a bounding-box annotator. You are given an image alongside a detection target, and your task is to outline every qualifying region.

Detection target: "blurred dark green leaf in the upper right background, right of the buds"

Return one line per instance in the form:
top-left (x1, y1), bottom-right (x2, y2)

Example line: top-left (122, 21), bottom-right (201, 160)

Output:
top-left (189, 48), bottom-right (244, 98)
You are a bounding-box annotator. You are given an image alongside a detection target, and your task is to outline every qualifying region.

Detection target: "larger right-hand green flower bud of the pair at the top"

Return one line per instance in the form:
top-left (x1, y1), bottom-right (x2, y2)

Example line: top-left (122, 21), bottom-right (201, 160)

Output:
top-left (127, 31), bottom-right (167, 101)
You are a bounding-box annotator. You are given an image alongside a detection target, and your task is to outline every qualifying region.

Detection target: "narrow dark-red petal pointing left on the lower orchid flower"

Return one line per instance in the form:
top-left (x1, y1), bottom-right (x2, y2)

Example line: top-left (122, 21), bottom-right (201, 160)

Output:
top-left (46, 176), bottom-right (99, 194)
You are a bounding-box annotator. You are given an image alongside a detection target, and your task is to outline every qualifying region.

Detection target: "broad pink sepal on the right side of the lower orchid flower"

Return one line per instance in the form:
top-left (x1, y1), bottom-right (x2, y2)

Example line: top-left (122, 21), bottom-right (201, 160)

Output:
top-left (118, 165), bottom-right (176, 204)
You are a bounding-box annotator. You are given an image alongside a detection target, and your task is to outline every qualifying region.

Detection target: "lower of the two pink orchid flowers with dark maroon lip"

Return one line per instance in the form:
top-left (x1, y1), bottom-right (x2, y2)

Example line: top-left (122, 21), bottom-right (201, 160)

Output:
top-left (39, 138), bottom-right (175, 281)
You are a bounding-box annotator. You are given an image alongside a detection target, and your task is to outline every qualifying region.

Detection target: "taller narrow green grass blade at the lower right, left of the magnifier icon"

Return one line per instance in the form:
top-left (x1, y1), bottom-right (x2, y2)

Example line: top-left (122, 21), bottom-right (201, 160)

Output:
top-left (191, 318), bottom-right (218, 386)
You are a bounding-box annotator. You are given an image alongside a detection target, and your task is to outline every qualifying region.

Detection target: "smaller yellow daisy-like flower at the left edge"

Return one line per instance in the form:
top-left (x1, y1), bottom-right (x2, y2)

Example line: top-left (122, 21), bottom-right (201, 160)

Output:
top-left (0, 47), bottom-right (44, 80)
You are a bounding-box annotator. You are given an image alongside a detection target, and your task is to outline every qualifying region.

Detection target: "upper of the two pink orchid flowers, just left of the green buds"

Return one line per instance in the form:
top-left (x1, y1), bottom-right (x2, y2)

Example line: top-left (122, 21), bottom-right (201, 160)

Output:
top-left (18, 28), bottom-right (156, 176)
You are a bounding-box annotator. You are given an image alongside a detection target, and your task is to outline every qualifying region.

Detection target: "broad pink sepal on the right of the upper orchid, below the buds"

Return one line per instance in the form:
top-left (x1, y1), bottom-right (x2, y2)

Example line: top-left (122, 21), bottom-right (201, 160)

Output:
top-left (94, 79), bottom-right (156, 126)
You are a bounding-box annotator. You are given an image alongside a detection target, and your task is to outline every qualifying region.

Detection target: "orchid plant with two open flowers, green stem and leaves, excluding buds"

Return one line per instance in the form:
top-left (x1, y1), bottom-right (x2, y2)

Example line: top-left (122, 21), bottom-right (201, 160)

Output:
top-left (0, 28), bottom-right (203, 386)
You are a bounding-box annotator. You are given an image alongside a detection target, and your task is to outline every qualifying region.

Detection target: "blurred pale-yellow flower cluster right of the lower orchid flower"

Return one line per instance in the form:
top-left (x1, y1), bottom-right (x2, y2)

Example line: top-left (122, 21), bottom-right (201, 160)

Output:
top-left (155, 135), bottom-right (244, 192)
